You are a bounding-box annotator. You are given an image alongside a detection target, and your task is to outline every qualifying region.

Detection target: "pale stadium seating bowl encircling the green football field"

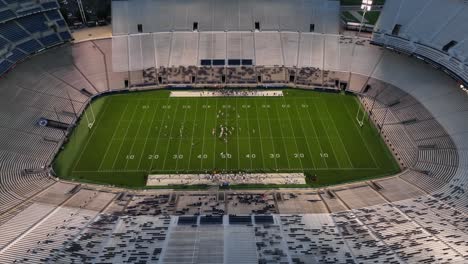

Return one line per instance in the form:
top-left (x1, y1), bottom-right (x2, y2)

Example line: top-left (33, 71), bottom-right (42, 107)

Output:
top-left (0, 0), bottom-right (468, 263)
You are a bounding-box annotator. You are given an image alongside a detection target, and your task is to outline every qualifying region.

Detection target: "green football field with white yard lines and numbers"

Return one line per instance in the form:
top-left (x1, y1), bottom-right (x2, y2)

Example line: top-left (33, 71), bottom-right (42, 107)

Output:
top-left (54, 89), bottom-right (399, 187)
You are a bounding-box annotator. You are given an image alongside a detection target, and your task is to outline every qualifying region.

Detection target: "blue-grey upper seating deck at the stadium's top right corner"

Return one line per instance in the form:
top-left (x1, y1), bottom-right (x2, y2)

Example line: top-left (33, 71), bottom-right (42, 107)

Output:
top-left (373, 0), bottom-right (468, 83)
